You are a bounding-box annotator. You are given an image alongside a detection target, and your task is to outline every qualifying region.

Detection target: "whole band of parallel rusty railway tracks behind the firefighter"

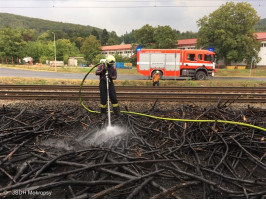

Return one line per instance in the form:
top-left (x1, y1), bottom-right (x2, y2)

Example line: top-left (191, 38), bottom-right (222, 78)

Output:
top-left (0, 85), bottom-right (266, 103)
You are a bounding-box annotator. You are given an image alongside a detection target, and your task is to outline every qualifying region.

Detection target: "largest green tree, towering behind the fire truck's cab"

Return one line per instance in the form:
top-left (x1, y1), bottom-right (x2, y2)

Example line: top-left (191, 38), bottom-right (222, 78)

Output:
top-left (197, 2), bottom-right (260, 64)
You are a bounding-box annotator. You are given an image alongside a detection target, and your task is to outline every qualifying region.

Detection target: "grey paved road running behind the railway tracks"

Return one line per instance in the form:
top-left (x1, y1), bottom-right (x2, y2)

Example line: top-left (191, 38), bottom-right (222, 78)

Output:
top-left (0, 67), bottom-right (266, 81)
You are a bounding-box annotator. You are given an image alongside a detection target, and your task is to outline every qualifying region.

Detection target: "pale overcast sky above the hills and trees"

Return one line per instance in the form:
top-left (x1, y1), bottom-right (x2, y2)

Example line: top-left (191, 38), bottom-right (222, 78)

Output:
top-left (0, 0), bottom-right (266, 36)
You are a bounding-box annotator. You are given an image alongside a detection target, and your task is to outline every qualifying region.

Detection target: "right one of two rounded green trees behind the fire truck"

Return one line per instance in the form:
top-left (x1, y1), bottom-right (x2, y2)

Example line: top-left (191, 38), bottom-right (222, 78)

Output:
top-left (153, 26), bottom-right (177, 49)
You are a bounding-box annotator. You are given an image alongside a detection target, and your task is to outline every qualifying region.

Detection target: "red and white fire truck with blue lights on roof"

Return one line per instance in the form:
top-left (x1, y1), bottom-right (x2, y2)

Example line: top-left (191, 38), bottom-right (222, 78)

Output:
top-left (137, 49), bottom-right (215, 80)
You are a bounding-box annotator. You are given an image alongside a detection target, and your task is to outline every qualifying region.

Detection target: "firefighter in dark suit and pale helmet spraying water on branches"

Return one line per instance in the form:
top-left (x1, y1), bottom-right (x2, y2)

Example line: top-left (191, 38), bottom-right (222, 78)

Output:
top-left (96, 55), bottom-right (120, 120)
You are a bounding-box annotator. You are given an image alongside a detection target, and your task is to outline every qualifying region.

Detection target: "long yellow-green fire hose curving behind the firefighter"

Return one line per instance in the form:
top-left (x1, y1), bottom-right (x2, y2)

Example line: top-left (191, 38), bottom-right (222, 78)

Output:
top-left (79, 63), bottom-right (266, 132)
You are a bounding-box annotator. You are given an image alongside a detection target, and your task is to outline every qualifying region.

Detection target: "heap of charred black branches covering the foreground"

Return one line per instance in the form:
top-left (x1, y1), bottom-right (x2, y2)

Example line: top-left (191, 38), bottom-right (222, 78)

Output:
top-left (0, 104), bottom-right (266, 199)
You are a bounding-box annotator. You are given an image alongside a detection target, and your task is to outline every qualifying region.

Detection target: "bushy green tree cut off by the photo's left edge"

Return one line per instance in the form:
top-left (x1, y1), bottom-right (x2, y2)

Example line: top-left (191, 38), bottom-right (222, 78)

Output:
top-left (0, 28), bottom-right (26, 60)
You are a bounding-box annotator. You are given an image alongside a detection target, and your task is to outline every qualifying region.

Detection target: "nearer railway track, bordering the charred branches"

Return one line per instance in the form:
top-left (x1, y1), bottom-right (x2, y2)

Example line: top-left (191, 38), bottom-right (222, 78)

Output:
top-left (0, 90), bottom-right (266, 103)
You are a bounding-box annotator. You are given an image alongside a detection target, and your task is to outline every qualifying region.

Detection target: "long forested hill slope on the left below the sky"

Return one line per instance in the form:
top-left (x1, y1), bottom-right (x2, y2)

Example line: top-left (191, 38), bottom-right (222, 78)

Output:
top-left (0, 13), bottom-right (102, 37)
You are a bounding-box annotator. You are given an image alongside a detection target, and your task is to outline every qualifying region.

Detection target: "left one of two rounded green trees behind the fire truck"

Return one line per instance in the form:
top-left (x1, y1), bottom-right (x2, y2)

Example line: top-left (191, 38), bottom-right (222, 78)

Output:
top-left (135, 24), bottom-right (155, 48)
